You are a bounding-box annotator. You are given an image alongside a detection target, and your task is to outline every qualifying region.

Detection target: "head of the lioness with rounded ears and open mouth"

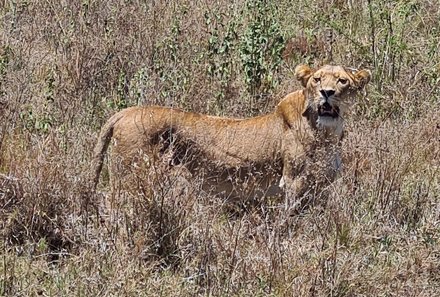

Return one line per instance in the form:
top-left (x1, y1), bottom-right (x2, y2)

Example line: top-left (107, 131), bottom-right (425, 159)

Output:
top-left (295, 65), bottom-right (371, 127)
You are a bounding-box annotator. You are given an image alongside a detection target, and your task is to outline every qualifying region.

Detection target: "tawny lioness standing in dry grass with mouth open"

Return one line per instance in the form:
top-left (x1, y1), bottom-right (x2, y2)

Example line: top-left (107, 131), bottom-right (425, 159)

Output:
top-left (92, 65), bottom-right (370, 201)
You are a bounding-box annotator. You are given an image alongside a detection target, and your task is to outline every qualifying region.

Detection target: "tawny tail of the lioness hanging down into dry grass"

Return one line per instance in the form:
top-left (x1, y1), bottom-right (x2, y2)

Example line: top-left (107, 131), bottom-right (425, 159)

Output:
top-left (91, 112), bottom-right (124, 191)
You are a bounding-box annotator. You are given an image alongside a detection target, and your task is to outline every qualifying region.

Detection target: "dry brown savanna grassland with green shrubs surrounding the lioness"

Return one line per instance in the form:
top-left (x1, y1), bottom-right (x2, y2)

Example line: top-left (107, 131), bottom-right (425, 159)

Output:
top-left (0, 0), bottom-right (440, 296)
